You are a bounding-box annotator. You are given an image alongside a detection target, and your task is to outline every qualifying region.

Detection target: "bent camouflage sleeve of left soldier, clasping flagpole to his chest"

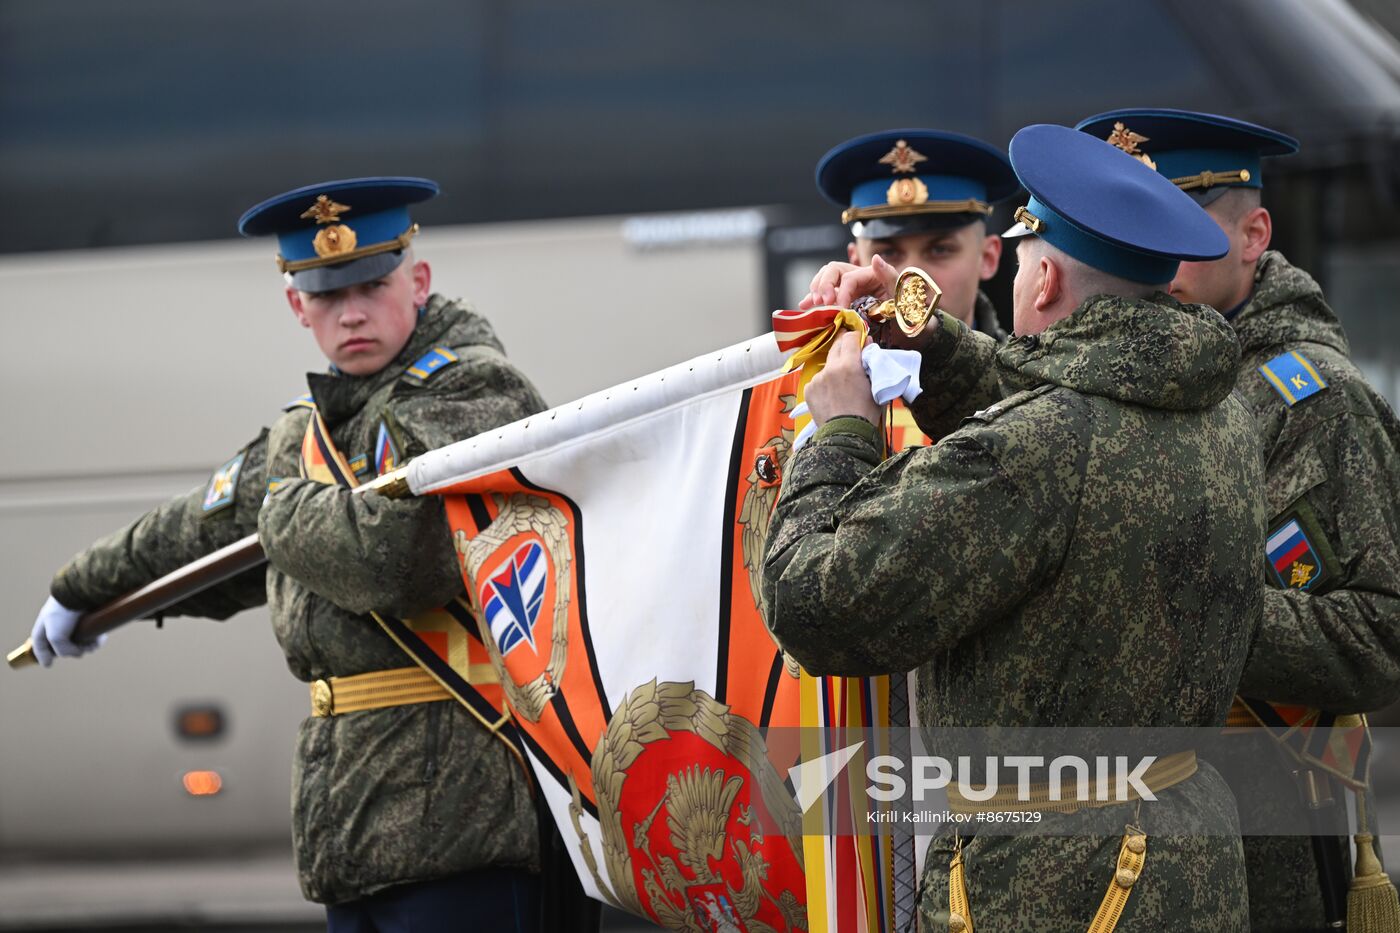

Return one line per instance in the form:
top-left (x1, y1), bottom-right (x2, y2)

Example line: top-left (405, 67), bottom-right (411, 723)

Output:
top-left (258, 349), bottom-right (543, 616)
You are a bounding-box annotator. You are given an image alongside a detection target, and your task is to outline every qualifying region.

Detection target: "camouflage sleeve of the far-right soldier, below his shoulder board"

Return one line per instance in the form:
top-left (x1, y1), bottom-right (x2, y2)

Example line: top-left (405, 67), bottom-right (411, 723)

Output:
top-left (1240, 410), bottom-right (1400, 712)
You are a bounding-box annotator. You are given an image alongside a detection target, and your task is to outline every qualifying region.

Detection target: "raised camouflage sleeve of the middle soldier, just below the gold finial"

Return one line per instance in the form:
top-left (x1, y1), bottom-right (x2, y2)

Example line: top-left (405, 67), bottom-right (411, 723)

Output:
top-left (909, 311), bottom-right (1001, 438)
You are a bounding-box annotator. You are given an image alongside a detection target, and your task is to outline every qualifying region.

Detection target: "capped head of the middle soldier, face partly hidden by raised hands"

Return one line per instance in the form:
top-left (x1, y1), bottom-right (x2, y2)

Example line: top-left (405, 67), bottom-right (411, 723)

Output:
top-left (816, 129), bottom-right (1019, 340)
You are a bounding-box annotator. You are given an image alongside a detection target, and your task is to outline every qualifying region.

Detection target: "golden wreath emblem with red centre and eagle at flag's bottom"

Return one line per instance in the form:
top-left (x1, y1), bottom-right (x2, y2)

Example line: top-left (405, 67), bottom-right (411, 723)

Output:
top-left (568, 679), bottom-right (808, 933)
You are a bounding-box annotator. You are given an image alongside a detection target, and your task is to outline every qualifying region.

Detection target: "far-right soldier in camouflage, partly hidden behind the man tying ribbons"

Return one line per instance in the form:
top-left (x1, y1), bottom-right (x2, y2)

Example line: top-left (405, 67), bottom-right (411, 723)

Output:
top-left (1079, 109), bottom-right (1400, 930)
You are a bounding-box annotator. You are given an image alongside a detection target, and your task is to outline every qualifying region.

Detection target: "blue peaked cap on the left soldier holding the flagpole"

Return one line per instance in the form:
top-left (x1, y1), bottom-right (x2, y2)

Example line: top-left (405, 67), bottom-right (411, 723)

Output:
top-left (238, 177), bottom-right (438, 291)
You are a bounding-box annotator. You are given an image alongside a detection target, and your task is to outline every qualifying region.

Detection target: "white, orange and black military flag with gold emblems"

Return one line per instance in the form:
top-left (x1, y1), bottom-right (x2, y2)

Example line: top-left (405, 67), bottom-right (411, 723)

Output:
top-left (389, 316), bottom-right (918, 930)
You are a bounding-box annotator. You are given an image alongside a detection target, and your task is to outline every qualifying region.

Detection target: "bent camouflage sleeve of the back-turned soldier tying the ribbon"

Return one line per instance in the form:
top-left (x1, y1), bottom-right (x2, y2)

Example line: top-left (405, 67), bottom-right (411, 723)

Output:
top-left (763, 403), bottom-right (1078, 677)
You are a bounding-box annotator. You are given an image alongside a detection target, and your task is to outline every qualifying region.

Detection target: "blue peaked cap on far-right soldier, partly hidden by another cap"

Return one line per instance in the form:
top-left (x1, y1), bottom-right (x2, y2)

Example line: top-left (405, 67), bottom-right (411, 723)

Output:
top-left (1075, 108), bottom-right (1298, 205)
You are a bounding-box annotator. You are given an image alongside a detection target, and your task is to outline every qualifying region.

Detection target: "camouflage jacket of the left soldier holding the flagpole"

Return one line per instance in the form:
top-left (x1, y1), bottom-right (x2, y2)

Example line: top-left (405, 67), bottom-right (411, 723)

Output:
top-left (52, 296), bottom-right (543, 904)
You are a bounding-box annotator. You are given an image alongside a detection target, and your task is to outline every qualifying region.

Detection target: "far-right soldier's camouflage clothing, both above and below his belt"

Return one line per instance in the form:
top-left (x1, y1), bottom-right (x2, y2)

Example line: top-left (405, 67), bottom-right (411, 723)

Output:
top-left (1215, 252), bottom-right (1400, 930)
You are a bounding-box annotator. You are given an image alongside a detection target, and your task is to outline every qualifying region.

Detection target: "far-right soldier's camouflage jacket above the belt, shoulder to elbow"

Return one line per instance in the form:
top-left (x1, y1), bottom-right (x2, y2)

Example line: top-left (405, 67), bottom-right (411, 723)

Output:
top-left (1233, 252), bottom-right (1400, 712)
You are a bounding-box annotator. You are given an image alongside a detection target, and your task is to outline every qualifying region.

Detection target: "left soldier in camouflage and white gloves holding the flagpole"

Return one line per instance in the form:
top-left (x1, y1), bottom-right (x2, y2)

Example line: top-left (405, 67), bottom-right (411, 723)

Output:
top-left (32, 179), bottom-right (557, 933)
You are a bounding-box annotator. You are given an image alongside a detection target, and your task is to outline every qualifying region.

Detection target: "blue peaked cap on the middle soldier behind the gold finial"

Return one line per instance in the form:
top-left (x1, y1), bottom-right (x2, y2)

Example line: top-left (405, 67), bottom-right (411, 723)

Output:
top-left (816, 129), bottom-right (1019, 238)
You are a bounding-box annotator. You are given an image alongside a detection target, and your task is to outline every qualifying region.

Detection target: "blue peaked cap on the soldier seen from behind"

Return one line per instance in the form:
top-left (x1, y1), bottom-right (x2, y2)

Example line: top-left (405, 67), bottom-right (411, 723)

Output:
top-left (1004, 123), bottom-right (1229, 284)
